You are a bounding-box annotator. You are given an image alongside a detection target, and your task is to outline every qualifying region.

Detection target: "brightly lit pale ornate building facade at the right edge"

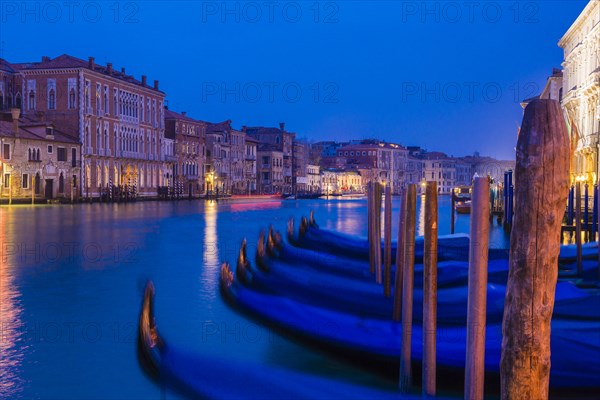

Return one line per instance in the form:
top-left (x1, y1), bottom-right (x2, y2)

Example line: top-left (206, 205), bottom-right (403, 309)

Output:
top-left (558, 1), bottom-right (600, 184)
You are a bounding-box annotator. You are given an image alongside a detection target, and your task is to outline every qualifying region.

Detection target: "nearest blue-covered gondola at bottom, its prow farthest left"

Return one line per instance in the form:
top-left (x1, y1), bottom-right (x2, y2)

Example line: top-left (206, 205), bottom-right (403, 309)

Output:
top-left (137, 283), bottom-right (416, 400)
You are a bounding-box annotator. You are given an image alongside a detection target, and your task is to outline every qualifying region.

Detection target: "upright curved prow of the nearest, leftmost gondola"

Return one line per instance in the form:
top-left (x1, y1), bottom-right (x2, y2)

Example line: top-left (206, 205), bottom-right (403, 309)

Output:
top-left (137, 281), bottom-right (164, 380)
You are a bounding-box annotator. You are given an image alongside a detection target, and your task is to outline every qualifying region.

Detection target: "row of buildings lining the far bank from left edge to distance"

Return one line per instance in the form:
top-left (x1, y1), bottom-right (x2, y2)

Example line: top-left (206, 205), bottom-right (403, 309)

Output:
top-left (0, 55), bottom-right (511, 199)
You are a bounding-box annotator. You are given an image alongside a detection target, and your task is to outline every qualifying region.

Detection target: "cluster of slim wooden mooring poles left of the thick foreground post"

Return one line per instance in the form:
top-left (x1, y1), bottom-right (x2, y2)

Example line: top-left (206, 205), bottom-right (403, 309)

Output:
top-left (368, 178), bottom-right (490, 399)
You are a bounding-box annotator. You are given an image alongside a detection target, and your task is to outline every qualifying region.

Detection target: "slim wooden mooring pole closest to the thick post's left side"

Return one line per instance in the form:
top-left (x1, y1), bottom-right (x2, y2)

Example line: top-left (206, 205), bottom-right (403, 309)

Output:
top-left (465, 178), bottom-right (490, 400)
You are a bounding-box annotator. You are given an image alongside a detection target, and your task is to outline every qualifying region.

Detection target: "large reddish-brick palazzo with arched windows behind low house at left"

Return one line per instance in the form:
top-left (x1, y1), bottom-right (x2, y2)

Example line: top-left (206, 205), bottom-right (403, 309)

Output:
top-left (3, 55), bottom-right (172, 197)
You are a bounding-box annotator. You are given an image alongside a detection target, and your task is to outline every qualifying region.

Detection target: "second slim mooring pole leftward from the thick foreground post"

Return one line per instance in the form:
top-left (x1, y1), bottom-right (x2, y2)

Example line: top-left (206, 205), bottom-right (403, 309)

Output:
top-left (421, 181), bottom-right (438, 397)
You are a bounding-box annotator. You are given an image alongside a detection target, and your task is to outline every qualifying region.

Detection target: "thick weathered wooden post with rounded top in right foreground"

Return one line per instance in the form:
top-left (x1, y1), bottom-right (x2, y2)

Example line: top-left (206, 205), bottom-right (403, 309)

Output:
top-left (500, 100), bottom-right (571, 399)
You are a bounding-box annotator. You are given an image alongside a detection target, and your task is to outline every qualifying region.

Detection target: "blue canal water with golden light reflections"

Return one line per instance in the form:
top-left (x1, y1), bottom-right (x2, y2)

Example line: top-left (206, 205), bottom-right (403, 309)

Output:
top-left (0, 197), bottom-right (508, 399)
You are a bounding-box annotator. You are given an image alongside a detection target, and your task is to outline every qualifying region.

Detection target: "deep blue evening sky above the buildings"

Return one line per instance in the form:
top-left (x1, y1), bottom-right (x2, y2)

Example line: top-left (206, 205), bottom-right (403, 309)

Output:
top-left (0, 0), bottom-right (587, 158)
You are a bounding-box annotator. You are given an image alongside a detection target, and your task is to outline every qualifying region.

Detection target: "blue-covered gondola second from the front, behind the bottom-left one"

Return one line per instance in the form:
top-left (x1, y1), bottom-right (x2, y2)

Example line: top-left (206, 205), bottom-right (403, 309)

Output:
top-left (220, 263), bottom-right (600, 389)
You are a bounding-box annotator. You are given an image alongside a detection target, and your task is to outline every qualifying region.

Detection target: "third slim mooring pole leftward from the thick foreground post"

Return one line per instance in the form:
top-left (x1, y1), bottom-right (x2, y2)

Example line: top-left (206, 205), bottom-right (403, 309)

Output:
top-left (400, 183), bottom-right (417, 393)
